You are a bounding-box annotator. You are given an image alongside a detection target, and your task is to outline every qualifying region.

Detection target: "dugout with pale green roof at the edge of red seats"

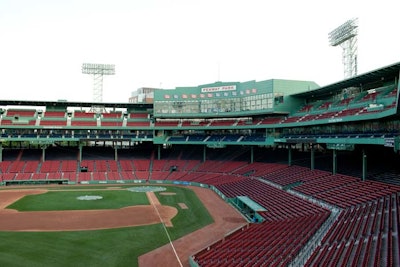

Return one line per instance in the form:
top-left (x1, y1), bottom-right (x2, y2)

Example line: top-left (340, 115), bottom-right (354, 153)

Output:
top-left (232, 196), bottom-right (267, 223)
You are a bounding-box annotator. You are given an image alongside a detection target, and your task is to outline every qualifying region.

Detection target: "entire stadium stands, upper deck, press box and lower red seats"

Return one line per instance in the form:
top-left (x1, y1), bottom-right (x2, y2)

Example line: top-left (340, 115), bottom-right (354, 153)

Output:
top-left (0, 63), bottom-right (400, 266)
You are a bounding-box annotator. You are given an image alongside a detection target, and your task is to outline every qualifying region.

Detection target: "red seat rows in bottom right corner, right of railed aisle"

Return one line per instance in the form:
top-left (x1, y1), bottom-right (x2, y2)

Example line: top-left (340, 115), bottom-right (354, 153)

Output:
top-left (306, 194), bottom-right (400, 266)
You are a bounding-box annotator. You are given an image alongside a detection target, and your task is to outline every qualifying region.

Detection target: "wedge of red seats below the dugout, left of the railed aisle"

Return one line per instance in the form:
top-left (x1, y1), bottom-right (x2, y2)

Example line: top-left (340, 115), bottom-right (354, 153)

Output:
top-left (195, 212), bottom-right (329, 267)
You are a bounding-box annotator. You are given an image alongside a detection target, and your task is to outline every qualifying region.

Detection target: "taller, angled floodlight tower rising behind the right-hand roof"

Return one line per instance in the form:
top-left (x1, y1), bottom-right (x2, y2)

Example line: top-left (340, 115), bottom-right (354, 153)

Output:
top-left (329, 18), bottom-right (358, 78)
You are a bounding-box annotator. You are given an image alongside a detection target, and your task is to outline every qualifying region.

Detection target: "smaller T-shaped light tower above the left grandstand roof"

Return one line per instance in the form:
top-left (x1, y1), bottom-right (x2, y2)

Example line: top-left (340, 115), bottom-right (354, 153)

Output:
top-left (82, 63), bottom-right (115, 103)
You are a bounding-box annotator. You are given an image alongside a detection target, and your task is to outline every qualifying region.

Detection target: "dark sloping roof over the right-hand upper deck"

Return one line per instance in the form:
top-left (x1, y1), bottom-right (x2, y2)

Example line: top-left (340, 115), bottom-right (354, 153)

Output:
top-left (293, 62), bottom-right (400, 98)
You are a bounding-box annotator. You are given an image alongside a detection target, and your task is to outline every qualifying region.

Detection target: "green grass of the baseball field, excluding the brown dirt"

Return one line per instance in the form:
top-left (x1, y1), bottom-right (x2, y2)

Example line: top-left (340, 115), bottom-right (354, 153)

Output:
top-left (0, 186), bottom-right (212, 267)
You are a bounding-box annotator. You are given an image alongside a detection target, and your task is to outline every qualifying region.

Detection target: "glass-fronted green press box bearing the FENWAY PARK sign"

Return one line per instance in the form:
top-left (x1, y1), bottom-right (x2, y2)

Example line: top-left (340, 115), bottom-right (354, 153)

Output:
top-left (154, 80), bottom-right (318, 118)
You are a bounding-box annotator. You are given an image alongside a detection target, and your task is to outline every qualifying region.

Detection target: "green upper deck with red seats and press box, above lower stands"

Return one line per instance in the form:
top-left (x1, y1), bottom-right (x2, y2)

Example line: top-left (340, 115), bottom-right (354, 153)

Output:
top-left (0, 63), bottom-right (400, 178)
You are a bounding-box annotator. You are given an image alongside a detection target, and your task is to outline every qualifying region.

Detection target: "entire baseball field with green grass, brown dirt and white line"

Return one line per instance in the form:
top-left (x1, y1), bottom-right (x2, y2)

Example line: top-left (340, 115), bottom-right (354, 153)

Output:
top-left (0, 185), bottom-right (244, 267)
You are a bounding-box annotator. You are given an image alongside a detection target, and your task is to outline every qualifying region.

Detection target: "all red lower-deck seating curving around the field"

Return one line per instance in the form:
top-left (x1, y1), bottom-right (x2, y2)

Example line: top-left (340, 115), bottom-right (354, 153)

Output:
top-left (0, 159), bottom-right (400, 267)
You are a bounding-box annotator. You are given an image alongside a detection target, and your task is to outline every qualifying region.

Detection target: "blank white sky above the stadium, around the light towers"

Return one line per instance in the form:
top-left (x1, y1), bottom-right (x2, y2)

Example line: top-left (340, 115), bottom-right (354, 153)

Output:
top-left (0, 0), bottom-right (400, 102)
